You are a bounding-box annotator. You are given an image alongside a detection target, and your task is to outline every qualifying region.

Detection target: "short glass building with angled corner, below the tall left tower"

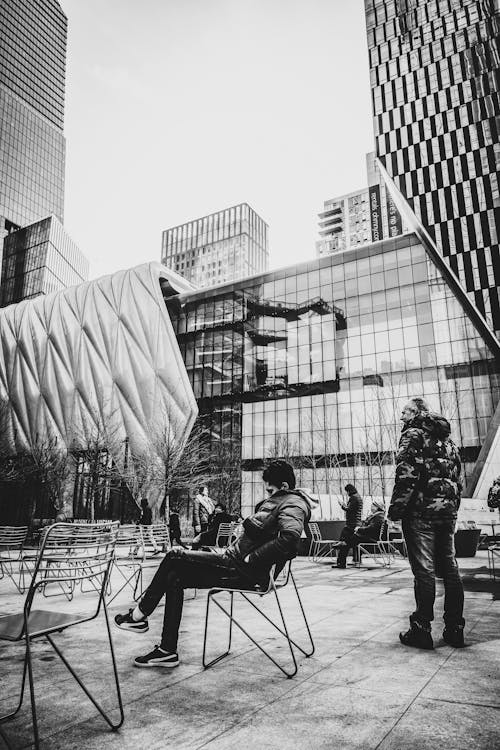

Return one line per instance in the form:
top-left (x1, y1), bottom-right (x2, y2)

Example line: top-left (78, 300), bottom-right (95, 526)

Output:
top-left (0, 216), bottom-right (89, 307)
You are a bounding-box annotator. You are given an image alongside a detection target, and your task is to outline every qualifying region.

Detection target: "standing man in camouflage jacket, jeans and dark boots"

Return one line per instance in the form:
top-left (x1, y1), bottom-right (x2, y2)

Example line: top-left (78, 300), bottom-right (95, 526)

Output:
top-left (388, 398), bottom-right (465, 649)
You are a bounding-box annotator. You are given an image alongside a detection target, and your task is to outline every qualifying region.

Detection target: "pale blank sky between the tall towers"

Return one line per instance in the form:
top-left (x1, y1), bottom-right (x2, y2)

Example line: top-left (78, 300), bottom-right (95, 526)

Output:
top-left (60, 0), bottom-right (373, 278)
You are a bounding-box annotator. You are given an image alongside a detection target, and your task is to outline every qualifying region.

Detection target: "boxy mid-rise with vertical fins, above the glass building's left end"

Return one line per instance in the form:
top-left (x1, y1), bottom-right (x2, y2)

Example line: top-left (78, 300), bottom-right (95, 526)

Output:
top-left (161, 203), bottom-right (269, 287)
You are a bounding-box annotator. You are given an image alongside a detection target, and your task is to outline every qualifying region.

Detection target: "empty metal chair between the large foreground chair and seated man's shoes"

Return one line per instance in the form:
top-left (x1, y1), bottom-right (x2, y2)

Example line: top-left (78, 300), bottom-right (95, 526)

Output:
top-left (107, 524), bottom-right (145, 605)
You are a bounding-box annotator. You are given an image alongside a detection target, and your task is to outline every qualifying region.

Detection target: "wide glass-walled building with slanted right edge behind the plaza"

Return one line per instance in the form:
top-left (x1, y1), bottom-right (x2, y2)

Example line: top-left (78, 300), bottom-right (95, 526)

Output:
top-left (167, 234), bottom-right (500, 517)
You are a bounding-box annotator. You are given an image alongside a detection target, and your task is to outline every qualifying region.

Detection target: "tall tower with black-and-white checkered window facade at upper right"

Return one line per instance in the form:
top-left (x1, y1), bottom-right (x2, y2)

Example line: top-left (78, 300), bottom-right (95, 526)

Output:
top-left (365, 0), bottom-right (500, 334)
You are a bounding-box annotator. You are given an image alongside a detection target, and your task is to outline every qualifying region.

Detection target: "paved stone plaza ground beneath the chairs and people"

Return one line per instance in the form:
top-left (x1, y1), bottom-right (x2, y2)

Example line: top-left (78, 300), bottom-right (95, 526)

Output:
top-left (0, 551), bottom-right (500, 750)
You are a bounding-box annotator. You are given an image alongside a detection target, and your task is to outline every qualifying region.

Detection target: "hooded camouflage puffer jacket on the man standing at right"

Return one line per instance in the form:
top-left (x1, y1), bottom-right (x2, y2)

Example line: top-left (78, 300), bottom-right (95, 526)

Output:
top-left (388, 414), bottom-right (462, 521)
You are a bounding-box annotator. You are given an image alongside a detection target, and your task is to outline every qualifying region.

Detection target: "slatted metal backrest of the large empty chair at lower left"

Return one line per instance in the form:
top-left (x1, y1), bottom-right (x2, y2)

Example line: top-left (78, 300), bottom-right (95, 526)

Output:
top-left (27, 521), bottom-right (119, 611)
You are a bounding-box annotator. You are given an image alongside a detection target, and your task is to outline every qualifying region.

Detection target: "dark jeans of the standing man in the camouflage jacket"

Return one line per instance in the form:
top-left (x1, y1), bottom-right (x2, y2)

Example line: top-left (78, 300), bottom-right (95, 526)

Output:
top-left (403, 516), bottom-right (464, 628)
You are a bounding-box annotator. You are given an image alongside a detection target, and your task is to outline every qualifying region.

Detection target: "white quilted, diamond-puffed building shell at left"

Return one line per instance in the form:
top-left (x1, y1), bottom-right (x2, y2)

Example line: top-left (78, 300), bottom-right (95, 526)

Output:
top-left (0, 263), bottom-right (197, 490)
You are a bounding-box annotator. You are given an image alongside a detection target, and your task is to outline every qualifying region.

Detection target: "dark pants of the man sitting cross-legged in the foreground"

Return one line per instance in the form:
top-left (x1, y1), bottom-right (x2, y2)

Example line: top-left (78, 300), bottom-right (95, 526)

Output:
top-left (139, 549), bottom-right (253, 653)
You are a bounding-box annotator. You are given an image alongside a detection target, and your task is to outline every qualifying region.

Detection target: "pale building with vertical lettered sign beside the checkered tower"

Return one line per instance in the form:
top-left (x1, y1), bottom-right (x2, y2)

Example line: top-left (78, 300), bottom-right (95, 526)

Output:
top-left (316, 151), bottom-right (408, 257)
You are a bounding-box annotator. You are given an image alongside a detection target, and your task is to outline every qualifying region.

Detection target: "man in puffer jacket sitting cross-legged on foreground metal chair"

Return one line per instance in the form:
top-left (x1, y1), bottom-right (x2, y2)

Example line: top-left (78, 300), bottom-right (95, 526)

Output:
top-left (115, 461), bottom-right (315, 668)
